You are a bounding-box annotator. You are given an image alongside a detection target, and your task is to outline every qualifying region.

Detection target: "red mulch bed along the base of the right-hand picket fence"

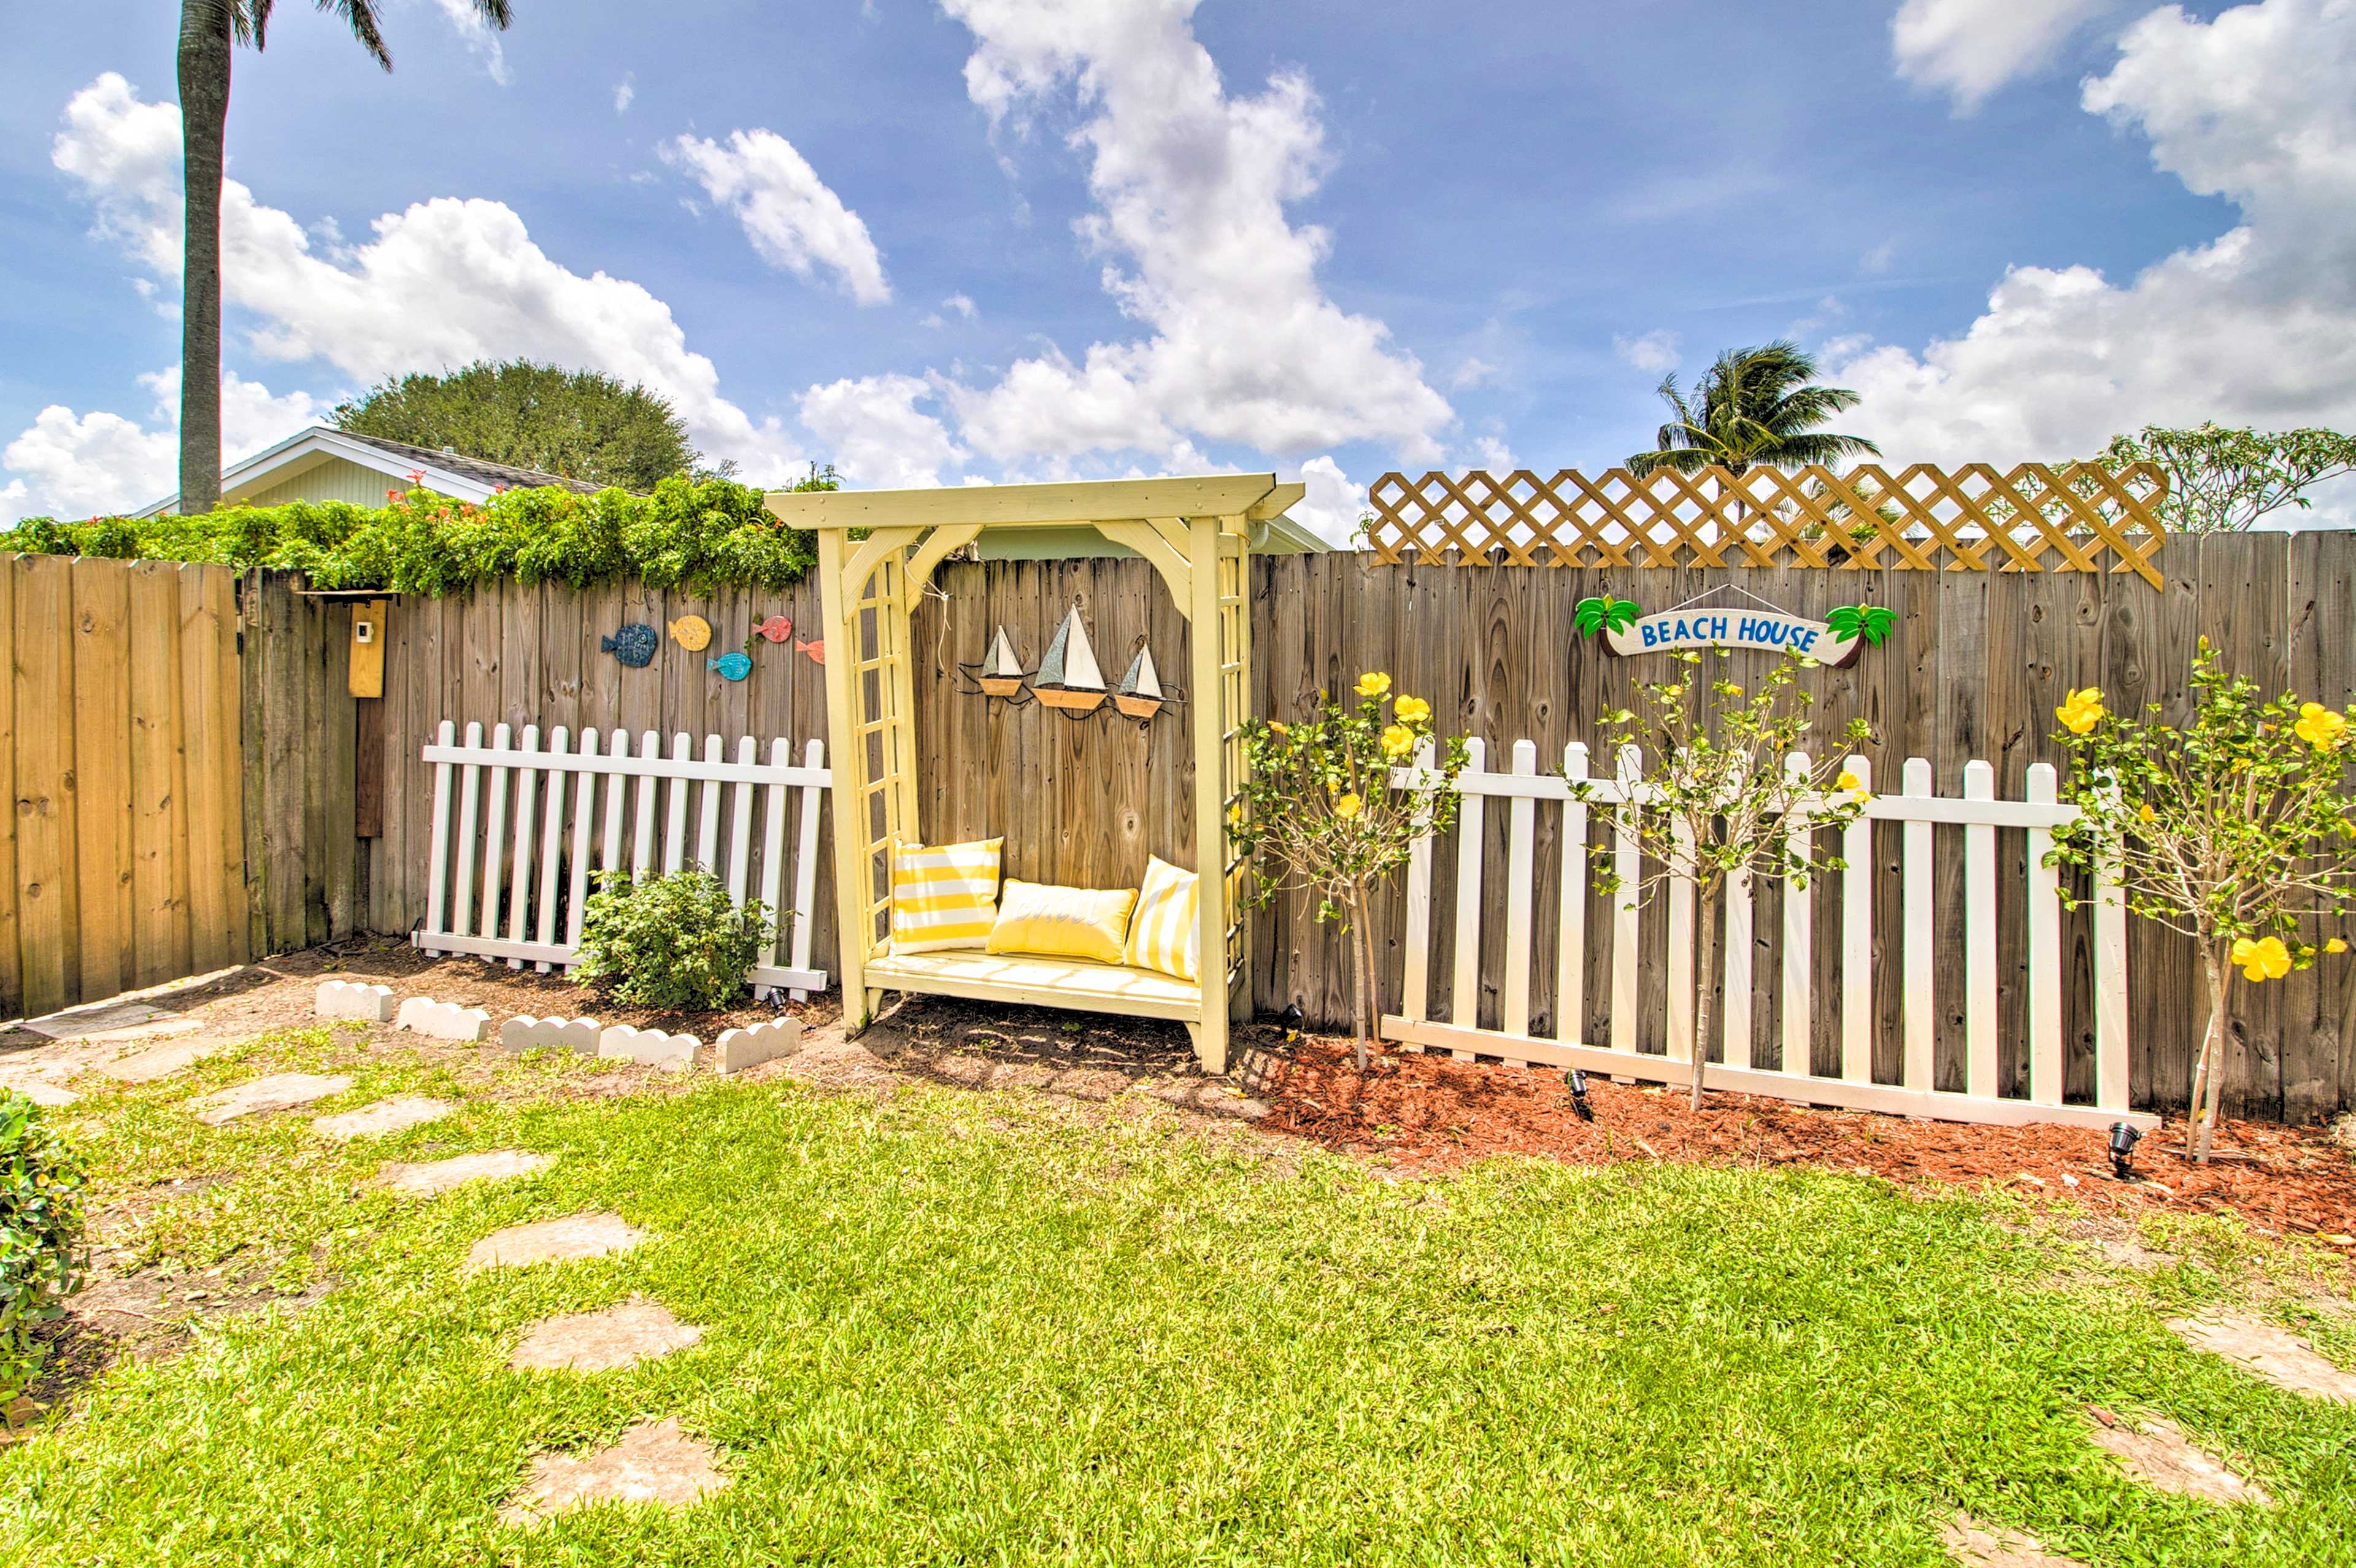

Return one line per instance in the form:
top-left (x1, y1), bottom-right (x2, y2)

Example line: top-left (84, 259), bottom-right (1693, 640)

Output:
top-left (1260, 1038), bottom-right (2356, 1245)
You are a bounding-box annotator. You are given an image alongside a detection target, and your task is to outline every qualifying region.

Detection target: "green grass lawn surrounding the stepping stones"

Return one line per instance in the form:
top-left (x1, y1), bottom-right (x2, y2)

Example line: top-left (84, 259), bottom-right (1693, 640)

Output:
top-left (0, 1034), bottom-right (2356, 1568)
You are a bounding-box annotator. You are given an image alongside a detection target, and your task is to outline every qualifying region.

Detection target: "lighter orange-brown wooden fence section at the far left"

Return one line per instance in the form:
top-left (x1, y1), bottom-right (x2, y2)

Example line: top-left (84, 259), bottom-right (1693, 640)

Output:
top-left (0, 556), bottom-right (250, 1017)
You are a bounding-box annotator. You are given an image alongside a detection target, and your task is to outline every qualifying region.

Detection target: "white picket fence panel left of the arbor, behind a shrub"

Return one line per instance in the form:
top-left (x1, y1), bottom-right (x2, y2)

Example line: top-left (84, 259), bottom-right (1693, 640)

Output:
top-left (410, 718), bottom-right (834, 1001)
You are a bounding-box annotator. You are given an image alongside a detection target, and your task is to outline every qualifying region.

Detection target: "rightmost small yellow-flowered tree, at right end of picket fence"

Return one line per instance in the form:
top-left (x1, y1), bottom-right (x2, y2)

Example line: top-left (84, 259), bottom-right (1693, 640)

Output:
top-left (2052, 638), bottom-right (2356, 1161)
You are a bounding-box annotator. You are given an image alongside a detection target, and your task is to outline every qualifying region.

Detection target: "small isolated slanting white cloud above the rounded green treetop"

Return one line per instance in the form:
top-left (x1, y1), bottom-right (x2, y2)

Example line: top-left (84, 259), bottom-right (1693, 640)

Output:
top-left (662, 129), bottom-right (891, 304)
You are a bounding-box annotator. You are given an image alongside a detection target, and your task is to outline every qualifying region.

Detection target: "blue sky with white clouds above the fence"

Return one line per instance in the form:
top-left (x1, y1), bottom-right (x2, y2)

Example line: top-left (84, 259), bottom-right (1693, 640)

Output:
top-left (0, 0), bottom-right (2356, 525)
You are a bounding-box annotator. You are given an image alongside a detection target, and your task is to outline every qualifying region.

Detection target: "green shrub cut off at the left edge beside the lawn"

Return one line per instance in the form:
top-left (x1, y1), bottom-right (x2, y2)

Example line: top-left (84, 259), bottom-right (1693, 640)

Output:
top-left (0, 1090), bottom-right (87, 1401)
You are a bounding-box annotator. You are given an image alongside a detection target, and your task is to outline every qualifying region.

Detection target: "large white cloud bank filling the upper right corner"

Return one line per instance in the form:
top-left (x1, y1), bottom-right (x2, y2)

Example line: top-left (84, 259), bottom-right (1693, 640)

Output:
top-left (1828, 0), bottom-right (2356, 461)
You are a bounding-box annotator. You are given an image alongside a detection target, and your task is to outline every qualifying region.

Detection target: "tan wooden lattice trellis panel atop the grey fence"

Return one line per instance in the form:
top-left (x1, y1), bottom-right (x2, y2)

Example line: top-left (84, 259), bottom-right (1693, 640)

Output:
top-left (1366, 464), bottom-right (2168, 588)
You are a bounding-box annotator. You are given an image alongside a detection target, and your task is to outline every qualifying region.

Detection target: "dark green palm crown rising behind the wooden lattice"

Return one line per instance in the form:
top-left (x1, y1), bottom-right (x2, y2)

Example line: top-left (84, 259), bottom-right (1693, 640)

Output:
top-left (1628, 339), bottom-right (1882, 478)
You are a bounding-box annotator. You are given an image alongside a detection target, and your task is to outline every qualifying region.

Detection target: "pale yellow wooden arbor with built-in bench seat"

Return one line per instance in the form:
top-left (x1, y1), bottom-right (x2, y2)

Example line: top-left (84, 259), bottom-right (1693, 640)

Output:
top-left (768, 473), bottom-right (1303, 1074)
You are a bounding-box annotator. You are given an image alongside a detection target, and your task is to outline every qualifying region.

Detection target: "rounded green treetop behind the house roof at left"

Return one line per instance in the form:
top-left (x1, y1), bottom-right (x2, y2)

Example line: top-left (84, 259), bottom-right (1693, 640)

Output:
top-left (334, 360), bottom-right (702, 494)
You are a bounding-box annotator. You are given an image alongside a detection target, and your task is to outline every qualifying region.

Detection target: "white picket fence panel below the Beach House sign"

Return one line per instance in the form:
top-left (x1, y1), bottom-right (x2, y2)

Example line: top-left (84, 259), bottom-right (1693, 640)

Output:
top-left (1383, 739), bottom-right (2156, 1128)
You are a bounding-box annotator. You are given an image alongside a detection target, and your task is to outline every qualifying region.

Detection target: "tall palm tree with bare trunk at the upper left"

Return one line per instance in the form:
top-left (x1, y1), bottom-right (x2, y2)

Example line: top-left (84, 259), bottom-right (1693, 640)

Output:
top-left (179, 0), bottom-right (509, 511)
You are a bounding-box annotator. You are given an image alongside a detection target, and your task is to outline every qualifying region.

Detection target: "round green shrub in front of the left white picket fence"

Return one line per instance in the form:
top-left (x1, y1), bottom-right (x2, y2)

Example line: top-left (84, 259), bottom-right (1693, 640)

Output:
top-left (572, 866), bottom-right (773, 1012)
